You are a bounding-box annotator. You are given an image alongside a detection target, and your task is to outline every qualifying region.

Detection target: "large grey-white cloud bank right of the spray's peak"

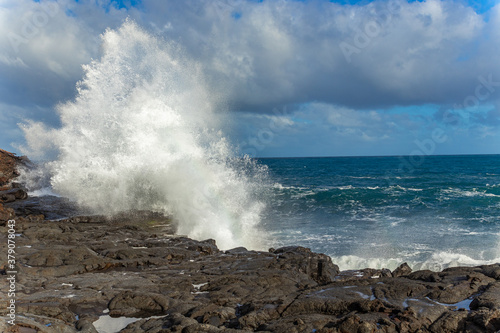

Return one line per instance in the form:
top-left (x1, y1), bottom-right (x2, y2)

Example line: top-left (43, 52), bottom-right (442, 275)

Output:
top-left (125, 0), bottom-right (500, 112)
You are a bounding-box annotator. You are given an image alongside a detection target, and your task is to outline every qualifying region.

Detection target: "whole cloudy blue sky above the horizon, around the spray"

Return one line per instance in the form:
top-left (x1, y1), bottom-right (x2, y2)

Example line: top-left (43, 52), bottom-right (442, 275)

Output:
top-left (0, 0), bottom-right (500, 157)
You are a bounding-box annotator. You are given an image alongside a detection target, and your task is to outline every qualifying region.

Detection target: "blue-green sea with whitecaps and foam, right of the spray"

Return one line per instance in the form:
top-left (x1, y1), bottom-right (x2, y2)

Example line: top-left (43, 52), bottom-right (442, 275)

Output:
top-left (258, 155), bottom-right (500, 270)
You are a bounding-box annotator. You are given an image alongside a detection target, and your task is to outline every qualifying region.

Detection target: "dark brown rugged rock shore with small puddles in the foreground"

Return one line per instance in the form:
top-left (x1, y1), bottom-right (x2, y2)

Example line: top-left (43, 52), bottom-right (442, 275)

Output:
top-left (0, 151), bottom-right (500, 333)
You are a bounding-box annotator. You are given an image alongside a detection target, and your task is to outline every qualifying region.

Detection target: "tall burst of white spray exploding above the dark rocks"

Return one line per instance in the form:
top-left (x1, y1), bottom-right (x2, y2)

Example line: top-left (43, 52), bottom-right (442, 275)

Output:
top-left (24, 21), bottom-right (264, 249)
